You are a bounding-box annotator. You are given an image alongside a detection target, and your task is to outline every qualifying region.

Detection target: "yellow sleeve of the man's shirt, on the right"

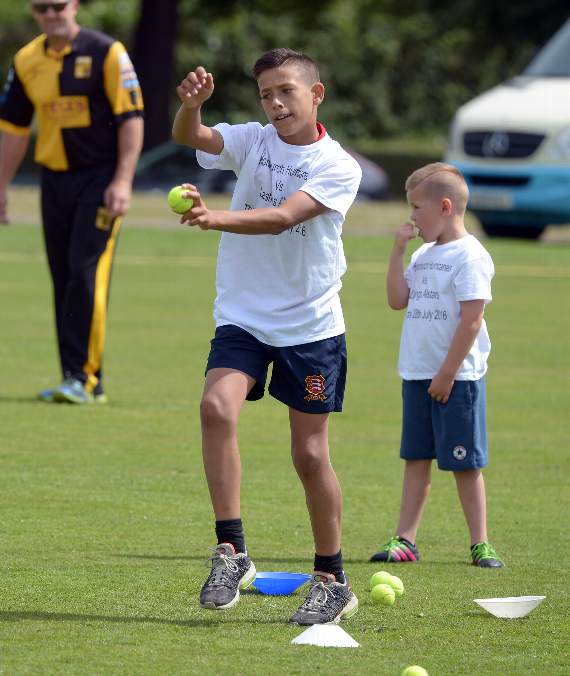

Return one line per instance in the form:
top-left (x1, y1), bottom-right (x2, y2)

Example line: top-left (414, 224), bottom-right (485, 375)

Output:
top-left (103, 42), bottom-right (143, 115)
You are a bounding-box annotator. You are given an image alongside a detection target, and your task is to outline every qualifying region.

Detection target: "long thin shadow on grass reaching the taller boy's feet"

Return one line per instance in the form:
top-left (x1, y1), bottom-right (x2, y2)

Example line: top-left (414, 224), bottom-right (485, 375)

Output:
top-left (0, 610), bottom-right (287, 628)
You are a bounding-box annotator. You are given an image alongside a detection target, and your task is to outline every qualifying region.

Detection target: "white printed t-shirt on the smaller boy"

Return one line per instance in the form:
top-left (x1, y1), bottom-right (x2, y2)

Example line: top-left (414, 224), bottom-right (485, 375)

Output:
top-left (398, 235), bottom-right (495, 380)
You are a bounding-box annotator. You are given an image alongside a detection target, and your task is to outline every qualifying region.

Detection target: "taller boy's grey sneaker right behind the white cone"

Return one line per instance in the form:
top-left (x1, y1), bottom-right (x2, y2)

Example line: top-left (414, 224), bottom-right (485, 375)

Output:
top-left (289, 572), bottom-right (358, 624)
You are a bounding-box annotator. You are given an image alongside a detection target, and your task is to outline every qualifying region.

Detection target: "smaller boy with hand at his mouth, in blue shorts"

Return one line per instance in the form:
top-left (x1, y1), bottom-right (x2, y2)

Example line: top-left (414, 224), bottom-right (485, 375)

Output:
top-left (370, 162), bottom-right (503, 568)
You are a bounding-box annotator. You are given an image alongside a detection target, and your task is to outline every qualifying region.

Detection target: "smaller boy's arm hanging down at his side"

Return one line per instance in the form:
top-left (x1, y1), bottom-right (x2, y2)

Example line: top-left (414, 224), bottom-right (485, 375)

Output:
top-left (428, 300), bottom-right (485, 404)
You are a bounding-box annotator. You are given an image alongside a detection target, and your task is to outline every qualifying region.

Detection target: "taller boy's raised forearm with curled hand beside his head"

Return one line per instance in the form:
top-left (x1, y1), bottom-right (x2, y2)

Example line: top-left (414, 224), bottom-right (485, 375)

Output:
top-left (172, 66), bottom-right (224, 155)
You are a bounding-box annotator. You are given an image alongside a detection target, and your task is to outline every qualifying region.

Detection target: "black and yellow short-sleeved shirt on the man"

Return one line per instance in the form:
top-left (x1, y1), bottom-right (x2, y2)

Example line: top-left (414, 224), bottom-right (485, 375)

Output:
top-left (0, 28), bottom-right (143, 171)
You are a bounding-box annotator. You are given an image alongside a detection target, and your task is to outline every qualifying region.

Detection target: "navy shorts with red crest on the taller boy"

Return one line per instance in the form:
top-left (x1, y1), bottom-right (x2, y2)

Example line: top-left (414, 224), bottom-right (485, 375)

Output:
top-left (206, 324), bottom-right (346, 413)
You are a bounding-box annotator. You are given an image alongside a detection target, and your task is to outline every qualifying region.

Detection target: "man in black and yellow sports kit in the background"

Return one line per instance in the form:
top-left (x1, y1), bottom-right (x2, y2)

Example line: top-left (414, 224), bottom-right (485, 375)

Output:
top-left (0, 0), bottom-right (143, 404)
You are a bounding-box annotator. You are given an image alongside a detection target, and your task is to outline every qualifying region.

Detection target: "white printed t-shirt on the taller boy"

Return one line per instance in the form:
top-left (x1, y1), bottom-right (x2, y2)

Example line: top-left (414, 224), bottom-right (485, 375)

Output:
top-left (196, 122), bottom-right (362, 347)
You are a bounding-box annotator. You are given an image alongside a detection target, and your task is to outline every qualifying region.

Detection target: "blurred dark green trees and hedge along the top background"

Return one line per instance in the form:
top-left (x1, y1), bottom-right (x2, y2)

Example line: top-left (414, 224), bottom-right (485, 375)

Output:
top-left (0, 0), bottom-right (568, 149)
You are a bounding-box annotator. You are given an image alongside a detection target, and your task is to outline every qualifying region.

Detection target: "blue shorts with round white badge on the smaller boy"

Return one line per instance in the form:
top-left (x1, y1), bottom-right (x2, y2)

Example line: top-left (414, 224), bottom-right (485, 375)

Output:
top-left (400, 378), bottom-right (488, 472)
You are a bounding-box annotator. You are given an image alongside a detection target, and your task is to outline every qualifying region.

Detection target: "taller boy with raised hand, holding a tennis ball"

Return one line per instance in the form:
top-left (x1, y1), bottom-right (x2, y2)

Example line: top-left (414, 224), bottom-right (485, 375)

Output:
top-left (173, 49), bottom-right (361, 624)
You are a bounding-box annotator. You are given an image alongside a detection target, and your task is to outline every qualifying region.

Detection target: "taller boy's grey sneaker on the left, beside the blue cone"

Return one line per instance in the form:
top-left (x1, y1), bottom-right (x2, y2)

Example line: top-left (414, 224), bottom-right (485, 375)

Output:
top-left (200, 542), bottom-right (256, 610)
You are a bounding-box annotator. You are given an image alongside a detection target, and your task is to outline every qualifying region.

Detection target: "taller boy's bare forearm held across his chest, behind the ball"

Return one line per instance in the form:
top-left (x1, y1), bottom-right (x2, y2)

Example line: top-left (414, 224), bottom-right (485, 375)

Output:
top-left (175, 183), bottom-right (328, 235)
